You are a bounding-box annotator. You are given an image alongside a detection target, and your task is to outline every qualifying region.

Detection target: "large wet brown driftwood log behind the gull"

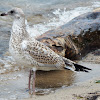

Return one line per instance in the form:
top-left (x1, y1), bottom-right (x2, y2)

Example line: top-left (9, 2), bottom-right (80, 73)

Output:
top-left (37, 10), bottom-right (100, 60)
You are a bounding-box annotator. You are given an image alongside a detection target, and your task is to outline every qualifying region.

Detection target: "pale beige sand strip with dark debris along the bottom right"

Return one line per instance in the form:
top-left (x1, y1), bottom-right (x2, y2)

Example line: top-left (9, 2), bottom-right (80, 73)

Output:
top-left (21, 77), bottom-right (100, 100)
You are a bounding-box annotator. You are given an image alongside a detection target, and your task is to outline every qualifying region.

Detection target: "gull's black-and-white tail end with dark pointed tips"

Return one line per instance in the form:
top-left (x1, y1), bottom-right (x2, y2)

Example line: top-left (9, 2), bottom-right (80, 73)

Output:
top-left (63, 57), bottom-right (91, 72)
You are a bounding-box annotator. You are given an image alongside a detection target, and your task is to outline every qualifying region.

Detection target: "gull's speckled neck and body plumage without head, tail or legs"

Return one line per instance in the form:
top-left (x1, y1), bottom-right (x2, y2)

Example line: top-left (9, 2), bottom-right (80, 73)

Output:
top-left (9, 8), bottom-right (66, 70)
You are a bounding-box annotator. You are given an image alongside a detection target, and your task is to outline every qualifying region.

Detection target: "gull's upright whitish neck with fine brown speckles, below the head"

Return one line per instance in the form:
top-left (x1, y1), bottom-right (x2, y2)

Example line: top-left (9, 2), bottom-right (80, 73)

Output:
top-left (11, 17), bottom-right (28, 41)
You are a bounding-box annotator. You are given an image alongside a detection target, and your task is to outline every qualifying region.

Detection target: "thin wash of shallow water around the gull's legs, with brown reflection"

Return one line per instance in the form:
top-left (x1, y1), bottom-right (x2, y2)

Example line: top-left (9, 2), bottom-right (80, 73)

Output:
top-left (0, 62), bottom-right (100, 100)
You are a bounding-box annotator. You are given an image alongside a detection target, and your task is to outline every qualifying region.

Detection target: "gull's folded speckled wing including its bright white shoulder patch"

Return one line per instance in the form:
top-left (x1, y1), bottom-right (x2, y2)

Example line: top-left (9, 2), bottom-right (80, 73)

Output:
top-left (22, 40), bottom-right (64, 67)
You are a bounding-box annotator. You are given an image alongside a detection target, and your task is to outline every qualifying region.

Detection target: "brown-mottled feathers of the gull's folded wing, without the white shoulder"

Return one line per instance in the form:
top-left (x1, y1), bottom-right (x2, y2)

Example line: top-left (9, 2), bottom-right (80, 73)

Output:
top-left (25, 40), bottom-right (59, 64)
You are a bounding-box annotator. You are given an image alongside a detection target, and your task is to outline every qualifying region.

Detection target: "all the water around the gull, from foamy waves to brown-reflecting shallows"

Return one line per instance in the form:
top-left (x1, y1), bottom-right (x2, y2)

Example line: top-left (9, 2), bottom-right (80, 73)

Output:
top-left (0, 0), bottom-right (100, 100)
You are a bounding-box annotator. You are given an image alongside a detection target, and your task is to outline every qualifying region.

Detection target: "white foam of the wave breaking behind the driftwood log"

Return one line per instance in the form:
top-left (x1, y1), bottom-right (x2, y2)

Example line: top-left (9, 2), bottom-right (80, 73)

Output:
top-left (30, 7), bottom-right (93, 36)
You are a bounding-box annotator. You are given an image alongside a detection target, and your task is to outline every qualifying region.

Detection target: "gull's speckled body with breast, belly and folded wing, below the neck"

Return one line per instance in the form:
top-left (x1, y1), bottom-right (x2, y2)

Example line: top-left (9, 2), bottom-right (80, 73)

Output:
top-left (9, 34), bottom-right (65, 70)
